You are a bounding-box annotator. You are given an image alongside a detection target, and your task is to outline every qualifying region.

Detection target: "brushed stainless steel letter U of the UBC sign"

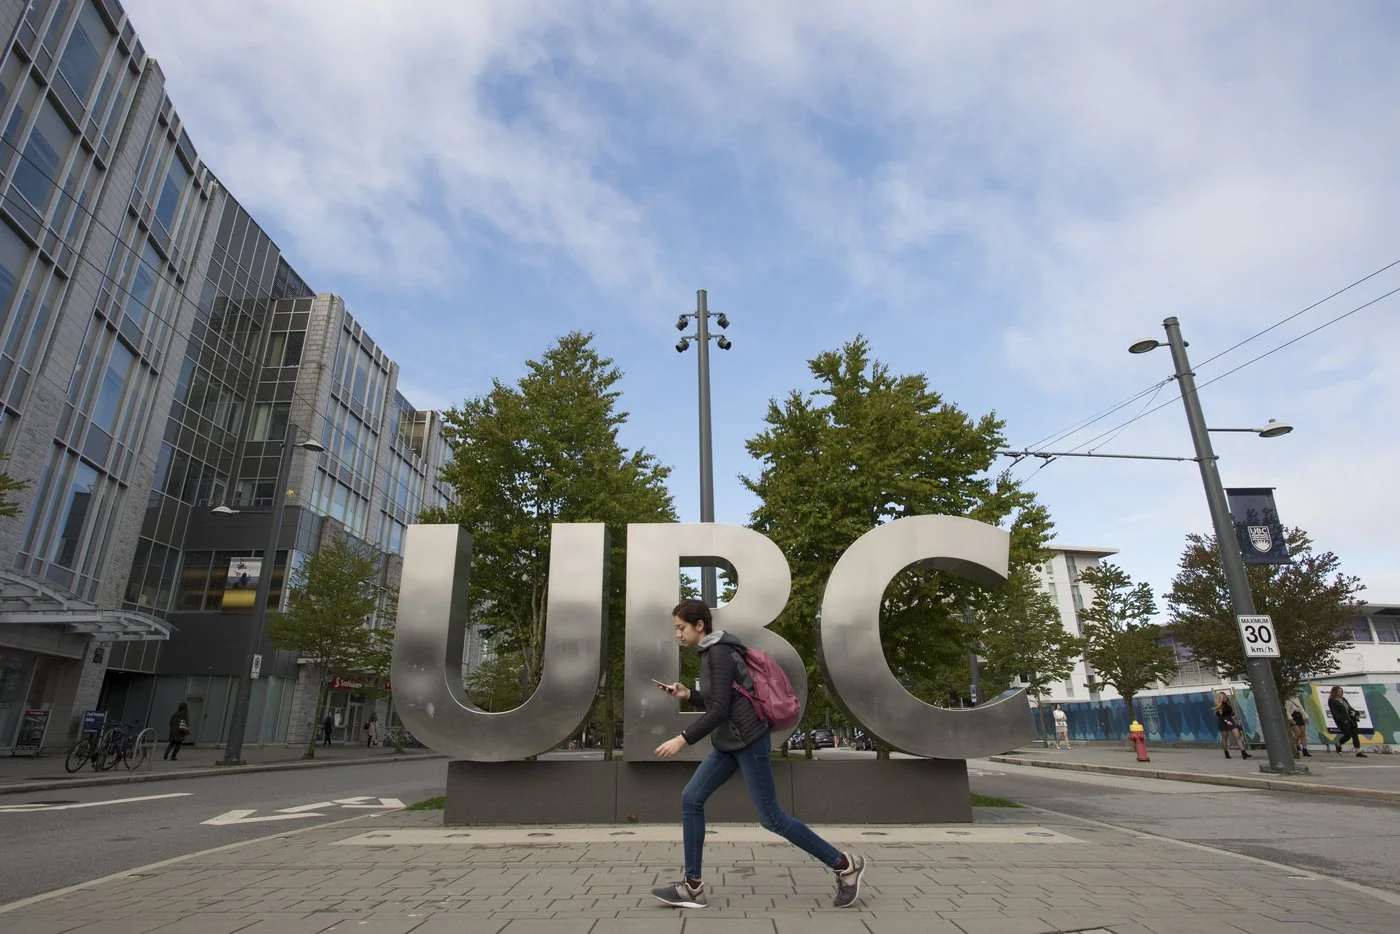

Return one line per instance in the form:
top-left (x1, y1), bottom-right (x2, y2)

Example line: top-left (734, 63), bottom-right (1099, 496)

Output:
top-left (392, 522), bottom-right (608, 762)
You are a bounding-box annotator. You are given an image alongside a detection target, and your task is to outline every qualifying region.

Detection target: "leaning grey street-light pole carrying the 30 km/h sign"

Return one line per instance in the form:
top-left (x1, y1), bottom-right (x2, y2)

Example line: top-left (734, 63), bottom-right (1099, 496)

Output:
top-left (1128, 318), bottom-right (1306, 774)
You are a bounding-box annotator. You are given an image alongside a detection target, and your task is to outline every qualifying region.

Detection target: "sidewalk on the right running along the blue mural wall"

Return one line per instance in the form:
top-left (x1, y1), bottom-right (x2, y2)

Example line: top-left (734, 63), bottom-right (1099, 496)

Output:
top-left (990, 744), bottom-right (1400, 804)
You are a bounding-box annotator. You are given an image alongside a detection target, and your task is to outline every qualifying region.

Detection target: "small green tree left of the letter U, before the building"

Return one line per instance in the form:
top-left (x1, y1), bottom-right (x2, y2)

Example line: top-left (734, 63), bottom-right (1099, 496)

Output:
top-left (267, 535), bottom-right (381, 759)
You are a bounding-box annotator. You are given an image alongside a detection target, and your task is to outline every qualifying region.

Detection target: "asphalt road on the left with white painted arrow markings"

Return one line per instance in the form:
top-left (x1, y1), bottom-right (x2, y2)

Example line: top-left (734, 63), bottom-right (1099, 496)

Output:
top-left (0, 759), bottom-right (447, 903)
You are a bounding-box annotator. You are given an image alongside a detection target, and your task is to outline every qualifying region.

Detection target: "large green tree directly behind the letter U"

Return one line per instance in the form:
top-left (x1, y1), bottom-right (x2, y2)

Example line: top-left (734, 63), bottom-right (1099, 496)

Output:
top-left (423, 332), bottom-right (675, 759)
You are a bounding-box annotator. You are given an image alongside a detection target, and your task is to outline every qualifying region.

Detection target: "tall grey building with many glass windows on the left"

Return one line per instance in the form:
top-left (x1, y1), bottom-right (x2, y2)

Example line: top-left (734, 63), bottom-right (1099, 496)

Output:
top-left (0, 0), bottom-right (448, 752)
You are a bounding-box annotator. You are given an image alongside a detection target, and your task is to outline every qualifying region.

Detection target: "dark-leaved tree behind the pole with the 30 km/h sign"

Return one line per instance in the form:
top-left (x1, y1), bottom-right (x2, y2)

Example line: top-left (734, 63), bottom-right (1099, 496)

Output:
top-left (1166, 528), bottom-right (1364, 697)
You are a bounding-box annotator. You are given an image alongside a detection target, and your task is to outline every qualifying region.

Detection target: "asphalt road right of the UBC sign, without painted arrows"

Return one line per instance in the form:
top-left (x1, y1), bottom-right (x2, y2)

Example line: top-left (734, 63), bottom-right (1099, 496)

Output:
top-left (969, 760), bottom-right (1400, 892)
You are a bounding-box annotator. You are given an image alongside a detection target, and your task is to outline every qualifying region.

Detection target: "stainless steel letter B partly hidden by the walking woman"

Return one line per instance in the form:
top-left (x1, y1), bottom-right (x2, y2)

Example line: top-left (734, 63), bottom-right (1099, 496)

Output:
top-left (623, 522), bottom-right (806, 762)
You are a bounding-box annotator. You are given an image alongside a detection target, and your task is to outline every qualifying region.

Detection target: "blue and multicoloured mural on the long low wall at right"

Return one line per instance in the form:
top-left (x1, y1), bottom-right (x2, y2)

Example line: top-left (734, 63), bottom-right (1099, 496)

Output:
top-left (1032, 682), bottom-right (1400, 746)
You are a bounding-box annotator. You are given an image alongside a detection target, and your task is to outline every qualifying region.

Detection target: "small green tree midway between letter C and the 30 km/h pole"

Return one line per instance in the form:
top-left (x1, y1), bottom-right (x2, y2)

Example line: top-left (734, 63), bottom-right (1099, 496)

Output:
top-left (1079, 562), bottom-right (1176, 718)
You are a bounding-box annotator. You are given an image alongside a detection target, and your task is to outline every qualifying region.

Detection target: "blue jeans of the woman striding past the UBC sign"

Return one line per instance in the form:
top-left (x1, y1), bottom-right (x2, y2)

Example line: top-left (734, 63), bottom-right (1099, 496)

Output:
top-left (680, 735), bottom-right (841, 879)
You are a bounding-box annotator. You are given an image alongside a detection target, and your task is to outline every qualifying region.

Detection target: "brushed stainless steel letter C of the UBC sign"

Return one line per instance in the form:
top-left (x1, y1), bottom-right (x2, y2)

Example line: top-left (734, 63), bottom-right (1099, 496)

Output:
top-left (817, 515), bottom-right (1032, 759)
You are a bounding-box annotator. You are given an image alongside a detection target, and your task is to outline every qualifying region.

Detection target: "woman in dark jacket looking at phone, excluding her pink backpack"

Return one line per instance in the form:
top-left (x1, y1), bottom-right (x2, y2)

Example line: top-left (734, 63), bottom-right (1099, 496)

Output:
top-left (651, 599), bottom-right (865, 907)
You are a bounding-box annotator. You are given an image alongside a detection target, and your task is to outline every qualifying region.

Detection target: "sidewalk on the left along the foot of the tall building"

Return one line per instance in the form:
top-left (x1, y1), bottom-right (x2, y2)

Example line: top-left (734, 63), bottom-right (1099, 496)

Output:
top-left (0, 742), bottom-right (438, 794)
